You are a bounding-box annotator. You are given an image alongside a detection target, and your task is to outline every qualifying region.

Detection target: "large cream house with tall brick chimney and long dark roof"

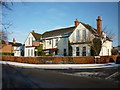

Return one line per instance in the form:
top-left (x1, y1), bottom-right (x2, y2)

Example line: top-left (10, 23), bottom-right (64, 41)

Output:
top-left (41, 16), bottom-right (112, 56)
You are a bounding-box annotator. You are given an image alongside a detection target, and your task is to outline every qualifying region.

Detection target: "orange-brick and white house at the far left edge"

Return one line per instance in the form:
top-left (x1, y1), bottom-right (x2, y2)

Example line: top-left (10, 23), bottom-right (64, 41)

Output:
top-left (0, 39), bottom-right (23, 56)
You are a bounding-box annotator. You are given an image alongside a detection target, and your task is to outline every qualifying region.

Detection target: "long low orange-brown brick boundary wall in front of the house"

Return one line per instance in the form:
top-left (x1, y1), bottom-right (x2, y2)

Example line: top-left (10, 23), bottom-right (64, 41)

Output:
top-left (1, 56), bottom-right (117, 64)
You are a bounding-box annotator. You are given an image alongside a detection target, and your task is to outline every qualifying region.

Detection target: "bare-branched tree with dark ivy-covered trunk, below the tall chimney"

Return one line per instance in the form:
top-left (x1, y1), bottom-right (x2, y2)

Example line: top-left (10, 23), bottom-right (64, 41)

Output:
top-left (84, 27), bottom-right (115, 56)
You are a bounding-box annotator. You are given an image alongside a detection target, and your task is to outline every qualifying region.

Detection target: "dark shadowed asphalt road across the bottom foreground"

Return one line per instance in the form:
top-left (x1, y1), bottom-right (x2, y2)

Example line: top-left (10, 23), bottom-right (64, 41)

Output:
top-left (2, 65), bottom-right (118, 89)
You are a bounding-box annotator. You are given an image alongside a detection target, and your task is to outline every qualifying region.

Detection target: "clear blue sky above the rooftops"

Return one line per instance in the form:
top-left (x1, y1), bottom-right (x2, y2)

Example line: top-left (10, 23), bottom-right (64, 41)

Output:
top-left (3, 2), bottom-right (118, 46)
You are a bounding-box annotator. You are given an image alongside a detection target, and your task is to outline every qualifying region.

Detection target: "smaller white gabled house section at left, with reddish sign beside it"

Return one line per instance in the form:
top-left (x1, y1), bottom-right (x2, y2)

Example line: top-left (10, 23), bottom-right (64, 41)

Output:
top-left (24, 30), bottom-right (42, 57)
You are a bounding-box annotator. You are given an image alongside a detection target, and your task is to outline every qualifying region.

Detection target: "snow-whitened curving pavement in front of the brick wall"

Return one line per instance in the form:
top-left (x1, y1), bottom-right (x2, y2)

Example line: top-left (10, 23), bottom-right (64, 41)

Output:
top-left (0, 61), bottom-right (120, 69)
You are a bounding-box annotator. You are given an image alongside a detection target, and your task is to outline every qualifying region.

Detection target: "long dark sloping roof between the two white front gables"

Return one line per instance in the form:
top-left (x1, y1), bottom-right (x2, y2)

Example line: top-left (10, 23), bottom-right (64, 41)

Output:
top-left (42, 26), bottom-right (76, 38)
